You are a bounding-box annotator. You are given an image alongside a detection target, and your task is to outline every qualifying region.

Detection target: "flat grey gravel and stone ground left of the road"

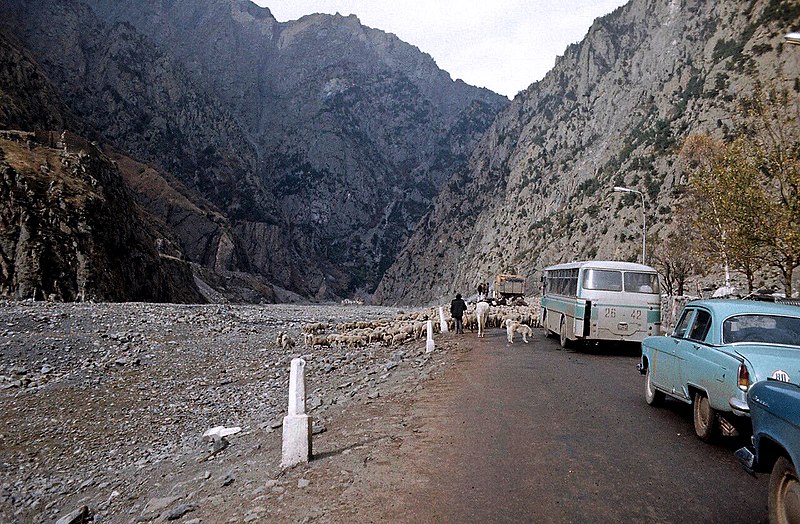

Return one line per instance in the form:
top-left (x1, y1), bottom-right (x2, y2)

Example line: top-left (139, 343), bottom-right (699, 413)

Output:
top-left (0, 301), bottom-right (476, 522)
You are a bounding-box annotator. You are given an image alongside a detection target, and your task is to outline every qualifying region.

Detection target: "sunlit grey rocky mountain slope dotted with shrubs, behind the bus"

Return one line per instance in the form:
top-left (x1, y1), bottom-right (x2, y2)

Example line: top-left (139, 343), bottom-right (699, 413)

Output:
top-left (376, 0), bottom-right (800, 303)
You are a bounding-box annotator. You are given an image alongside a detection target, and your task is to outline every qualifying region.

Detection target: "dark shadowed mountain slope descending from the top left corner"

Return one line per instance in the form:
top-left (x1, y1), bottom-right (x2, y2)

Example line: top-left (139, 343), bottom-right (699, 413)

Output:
top-left (0, 1), bottom-right (277, 290)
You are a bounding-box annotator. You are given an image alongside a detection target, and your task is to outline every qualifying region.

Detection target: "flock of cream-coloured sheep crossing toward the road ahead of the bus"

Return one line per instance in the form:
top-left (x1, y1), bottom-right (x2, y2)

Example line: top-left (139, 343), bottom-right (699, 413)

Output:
top-left (275, 304), bottom-right (539, 349)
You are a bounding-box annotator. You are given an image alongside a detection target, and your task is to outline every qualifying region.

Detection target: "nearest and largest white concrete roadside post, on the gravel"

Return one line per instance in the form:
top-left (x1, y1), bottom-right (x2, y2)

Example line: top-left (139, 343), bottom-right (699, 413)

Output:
top-left (281, 358), bottom-right (311, 468)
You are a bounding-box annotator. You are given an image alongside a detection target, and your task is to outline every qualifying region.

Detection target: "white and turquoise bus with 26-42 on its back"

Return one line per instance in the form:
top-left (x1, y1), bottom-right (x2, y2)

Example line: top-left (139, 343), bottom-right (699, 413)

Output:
top-left (540, 260), bottom-right (661, 348)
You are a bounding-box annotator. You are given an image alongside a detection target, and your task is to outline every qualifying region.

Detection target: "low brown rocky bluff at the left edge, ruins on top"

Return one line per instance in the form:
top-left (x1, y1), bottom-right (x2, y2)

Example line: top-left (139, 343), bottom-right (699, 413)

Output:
top-left (0, 132), bottom-right (203, 302)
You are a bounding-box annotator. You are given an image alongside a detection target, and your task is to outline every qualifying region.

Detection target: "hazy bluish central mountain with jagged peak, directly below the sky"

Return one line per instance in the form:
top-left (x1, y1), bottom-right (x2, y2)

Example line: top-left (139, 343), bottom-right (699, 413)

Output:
top-left (88, 0), bottom-right (507, 293)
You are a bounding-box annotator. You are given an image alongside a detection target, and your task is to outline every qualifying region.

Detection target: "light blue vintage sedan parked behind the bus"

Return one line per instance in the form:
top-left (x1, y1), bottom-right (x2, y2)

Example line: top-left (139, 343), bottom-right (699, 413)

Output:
top-left (637, 300), bottom-right (800, 442)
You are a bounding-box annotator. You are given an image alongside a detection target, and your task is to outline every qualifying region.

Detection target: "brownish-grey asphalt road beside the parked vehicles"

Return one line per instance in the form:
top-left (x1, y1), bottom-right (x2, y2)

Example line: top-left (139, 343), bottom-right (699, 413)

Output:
top-left (400, 330), bottom-right (768, 524)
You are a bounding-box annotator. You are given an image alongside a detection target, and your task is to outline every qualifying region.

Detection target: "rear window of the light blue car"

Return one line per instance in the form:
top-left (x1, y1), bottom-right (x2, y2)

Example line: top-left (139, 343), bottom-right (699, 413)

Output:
top-left (722, 315), bottom-right (800, 347)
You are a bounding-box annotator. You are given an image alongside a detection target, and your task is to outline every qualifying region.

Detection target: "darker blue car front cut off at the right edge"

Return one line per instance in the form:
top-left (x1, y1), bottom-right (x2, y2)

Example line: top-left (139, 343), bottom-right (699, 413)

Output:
top-left (736, 380), bottom-right (800, 524)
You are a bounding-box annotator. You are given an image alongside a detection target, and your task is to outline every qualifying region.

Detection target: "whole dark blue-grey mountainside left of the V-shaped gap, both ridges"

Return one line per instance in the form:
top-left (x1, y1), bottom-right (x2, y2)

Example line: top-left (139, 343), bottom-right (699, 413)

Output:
top-left (0, 0), bottom-right (507, 299)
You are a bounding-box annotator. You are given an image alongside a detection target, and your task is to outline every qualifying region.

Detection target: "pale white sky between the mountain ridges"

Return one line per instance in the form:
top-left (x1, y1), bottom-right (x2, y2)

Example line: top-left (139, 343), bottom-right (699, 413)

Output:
top-left (255, 0), bottom-right (627, 98)
